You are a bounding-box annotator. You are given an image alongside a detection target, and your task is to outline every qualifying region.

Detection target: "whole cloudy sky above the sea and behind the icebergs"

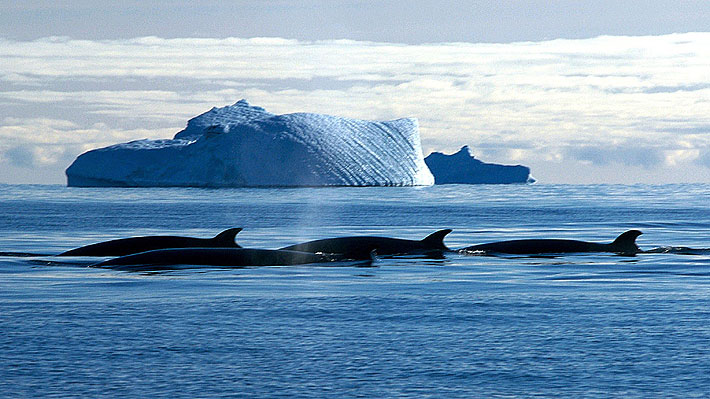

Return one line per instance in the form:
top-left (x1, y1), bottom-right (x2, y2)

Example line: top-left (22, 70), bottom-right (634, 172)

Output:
top-left (0, 0), bottom-right (710, 184)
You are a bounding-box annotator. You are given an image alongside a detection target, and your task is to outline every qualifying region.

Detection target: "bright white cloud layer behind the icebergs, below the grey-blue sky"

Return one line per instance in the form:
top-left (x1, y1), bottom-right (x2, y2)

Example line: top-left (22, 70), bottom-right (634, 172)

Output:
top-left (0, 33), bottom-right (710, 183)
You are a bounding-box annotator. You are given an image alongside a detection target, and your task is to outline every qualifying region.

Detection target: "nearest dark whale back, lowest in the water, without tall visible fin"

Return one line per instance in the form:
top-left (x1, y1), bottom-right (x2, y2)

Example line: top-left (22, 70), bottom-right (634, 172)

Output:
top-left (90, 248), bottom-right (362, 271)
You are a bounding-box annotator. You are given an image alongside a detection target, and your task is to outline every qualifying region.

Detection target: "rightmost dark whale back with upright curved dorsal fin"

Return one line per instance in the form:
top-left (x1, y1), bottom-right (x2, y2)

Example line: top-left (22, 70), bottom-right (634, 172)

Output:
top-left (459, 230), bottom-right (643, 255)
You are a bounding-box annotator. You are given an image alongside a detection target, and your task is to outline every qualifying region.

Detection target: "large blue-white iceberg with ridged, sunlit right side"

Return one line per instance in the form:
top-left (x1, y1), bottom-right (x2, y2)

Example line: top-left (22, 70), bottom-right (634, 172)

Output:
top-left (66, 100), bottom-right (434, 187)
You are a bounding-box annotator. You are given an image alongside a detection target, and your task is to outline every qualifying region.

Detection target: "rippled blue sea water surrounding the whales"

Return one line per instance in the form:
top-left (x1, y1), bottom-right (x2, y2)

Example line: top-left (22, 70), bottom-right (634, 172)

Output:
top-left (0, 185), bottom-right (710, 398)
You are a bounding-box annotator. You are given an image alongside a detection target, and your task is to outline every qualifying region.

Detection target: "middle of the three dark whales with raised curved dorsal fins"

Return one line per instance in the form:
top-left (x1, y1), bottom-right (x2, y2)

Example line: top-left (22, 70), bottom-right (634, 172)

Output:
top-left (281, 229), bottom-right (451, 259)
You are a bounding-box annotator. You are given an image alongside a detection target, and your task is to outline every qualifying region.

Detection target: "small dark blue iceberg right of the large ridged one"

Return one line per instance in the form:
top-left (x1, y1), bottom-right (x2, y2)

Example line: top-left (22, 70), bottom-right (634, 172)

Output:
top-left (424, 146), bottom-right (535, 184)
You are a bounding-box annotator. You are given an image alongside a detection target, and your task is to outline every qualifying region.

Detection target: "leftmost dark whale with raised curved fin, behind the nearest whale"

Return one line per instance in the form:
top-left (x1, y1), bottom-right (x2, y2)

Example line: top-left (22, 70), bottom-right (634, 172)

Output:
top-left (57, 228), bottom-right (242, 256)
